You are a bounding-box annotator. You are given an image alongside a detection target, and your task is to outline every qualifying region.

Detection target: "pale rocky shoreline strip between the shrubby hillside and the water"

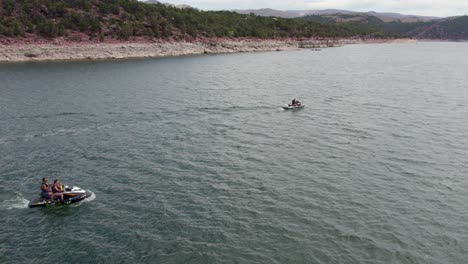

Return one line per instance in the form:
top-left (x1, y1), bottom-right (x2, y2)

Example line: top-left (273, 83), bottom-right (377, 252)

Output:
top-left (0, 38), bottom-right (413, 64)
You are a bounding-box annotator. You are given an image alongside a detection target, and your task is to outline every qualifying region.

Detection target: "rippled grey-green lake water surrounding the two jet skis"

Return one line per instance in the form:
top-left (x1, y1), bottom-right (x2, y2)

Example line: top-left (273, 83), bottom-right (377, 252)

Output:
top-left (0, 43), bottom-right (468, 264)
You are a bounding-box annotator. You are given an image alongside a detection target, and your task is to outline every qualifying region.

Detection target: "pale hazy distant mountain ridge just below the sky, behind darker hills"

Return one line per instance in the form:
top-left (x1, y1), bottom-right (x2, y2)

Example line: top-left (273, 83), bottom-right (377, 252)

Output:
top-left (233, 8), bottom-right (439, 22)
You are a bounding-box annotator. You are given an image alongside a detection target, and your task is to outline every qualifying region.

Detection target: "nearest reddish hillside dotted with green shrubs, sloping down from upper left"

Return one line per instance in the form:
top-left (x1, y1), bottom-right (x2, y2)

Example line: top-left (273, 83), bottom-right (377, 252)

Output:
top-left (0, 0), bottom-right (376, 41)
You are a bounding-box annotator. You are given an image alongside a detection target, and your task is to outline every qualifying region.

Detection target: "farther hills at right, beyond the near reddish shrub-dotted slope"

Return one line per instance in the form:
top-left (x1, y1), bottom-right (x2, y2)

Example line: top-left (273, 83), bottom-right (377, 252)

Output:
top-left (236, 9), bottom-right (468, 41)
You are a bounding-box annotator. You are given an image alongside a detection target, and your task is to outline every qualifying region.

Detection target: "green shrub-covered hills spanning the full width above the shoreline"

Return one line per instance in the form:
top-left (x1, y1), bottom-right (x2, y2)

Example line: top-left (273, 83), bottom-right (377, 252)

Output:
top-left (0, 0), bottom-right (468, 41)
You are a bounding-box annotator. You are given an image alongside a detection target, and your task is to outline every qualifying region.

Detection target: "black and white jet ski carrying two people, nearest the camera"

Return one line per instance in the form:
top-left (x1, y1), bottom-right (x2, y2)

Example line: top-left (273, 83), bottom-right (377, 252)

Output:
top-left (28, 186), bottom-right (92, 208)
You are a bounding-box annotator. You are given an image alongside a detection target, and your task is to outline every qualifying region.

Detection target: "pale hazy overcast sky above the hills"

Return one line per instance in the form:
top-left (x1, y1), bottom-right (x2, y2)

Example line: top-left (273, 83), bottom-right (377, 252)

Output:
top-left (161, 0), bottom-right (468, 16)
